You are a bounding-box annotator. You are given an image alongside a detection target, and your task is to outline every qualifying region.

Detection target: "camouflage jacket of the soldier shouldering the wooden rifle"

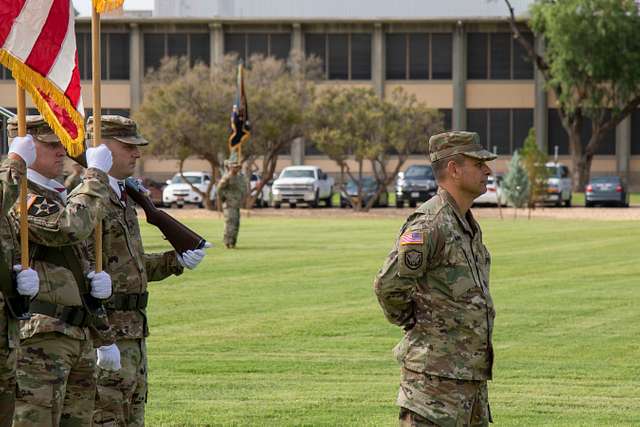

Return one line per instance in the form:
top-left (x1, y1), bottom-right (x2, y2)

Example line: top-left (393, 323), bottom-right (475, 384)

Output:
top-left (90, 183), bottom-right (183, 345)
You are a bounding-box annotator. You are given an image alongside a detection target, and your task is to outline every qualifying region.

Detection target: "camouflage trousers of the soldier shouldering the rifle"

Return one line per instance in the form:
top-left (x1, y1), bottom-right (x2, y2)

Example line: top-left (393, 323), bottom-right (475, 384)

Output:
top-left (93, 339), bottom-right (147, 426)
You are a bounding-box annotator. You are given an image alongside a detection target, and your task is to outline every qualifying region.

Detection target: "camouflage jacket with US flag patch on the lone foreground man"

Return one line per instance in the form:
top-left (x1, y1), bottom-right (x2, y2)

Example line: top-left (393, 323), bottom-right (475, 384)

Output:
top-left (374, 189), bottom-right (495, 380)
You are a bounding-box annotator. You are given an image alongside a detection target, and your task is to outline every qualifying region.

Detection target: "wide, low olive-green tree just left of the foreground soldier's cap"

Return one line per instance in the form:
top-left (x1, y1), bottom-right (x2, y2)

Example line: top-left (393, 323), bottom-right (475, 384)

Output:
top-left (308, 88), bottom-right (441, 210)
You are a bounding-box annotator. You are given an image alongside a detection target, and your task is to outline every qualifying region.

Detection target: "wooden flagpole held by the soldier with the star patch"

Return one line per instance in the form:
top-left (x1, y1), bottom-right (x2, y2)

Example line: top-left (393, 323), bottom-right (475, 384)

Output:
top-left (91, 5), bottom-right (102, 273)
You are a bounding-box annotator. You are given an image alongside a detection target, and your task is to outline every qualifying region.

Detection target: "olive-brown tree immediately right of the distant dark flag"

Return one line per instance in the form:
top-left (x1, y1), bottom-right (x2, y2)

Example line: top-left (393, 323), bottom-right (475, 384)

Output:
top-left (240, 53), bottom-right (320, 208)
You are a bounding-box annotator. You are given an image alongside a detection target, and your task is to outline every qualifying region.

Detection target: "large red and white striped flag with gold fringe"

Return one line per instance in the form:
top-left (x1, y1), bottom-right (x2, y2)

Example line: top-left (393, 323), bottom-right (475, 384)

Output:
top-left (0, 0), bottom-right (84, 156)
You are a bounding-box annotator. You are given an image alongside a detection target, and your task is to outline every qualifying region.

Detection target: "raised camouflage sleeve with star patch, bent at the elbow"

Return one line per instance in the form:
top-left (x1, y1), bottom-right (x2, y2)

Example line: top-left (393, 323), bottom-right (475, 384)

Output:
top-left (23, 168), bottom-right (109, 246)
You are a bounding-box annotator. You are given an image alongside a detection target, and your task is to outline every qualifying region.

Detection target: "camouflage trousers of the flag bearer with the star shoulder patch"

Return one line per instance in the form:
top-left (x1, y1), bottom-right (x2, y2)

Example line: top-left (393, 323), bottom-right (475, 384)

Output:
top-left (13, 332), bottom-right (96, 427)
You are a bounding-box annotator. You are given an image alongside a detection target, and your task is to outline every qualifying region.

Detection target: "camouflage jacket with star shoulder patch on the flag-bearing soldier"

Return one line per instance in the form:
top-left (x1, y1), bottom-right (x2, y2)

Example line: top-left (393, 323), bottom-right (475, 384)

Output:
top-left (12, 168), bottom-right (107, 340)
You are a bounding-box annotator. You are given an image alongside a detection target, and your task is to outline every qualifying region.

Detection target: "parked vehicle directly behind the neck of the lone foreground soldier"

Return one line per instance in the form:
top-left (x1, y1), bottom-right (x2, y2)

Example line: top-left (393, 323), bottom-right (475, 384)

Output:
top-left (396, 165), bottom-right (438, 208)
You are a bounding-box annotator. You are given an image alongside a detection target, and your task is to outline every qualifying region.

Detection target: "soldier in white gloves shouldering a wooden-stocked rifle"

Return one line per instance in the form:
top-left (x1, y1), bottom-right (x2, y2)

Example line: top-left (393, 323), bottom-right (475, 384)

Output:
top-left (87, 115), bottom-right (209, 426)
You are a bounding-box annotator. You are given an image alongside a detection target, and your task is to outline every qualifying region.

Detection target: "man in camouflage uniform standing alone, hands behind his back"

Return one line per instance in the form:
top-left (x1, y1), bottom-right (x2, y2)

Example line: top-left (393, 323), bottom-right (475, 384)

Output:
top-left (374, 132), bottom-right (496, 426)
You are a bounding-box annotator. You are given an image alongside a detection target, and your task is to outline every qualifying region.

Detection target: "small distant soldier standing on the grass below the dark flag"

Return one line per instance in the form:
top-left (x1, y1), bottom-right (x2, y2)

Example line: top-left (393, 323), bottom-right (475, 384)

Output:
top-left (218, 152), bottom-right (247, 249)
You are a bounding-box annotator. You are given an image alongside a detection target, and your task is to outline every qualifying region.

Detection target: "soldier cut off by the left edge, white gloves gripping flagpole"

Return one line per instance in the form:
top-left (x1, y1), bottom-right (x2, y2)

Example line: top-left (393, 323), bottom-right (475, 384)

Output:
top-left (0, 135), bottom-right (39, 427)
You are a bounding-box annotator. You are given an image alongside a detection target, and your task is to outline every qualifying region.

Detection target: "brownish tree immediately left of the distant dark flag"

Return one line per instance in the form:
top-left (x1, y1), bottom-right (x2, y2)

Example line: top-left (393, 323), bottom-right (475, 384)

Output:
top-left (134, 57), bottom-right (235, 209)
